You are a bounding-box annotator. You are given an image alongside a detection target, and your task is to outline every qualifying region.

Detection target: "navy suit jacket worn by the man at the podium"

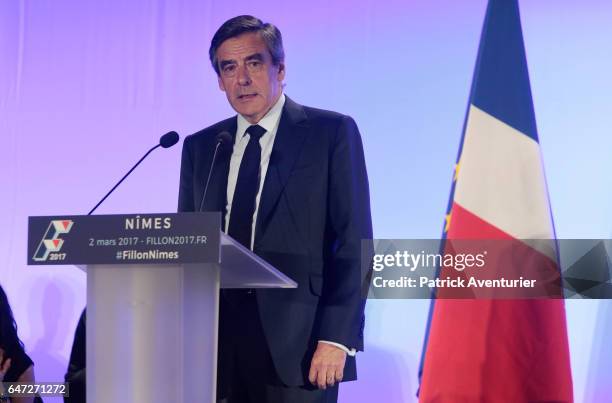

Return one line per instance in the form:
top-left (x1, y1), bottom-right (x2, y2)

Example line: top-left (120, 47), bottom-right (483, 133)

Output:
top-left (179, 97), bottom-right (372, 385)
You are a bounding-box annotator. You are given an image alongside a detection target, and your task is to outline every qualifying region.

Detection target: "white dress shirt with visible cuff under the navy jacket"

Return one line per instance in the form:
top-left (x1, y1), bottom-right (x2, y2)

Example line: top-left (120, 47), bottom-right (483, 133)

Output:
top-left (225, 94), bottom-right (356, 356)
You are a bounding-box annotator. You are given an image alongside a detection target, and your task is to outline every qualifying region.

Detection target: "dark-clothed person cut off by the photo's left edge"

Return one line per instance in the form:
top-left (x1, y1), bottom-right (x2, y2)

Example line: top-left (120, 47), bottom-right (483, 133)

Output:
top-left (0, 285), bottom-right (35, 403)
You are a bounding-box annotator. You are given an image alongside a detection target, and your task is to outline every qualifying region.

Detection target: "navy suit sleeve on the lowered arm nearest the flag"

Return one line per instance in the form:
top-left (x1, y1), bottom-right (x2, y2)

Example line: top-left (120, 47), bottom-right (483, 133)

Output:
top-left (318, 116), bottom-right (372, 350)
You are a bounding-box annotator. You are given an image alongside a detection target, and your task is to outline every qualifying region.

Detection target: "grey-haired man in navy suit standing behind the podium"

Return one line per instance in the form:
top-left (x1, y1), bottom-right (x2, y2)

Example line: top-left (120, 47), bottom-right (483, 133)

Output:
top-left (179, 16), bottom-right (372, 403)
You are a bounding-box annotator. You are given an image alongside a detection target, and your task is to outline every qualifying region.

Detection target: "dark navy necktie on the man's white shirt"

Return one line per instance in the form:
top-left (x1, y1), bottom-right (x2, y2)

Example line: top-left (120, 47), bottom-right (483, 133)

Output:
top-left (228, 125), bottom-right (266, 249)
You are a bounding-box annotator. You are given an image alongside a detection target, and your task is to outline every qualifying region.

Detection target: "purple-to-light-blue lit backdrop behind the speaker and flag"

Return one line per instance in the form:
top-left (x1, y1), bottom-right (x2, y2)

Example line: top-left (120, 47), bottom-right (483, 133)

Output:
top-left (0, 0), bottom-right (612, 403)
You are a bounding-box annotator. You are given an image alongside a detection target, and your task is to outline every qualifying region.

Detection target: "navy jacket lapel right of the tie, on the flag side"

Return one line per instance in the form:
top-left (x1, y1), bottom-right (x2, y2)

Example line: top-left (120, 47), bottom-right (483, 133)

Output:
top-left (255, 97), bottom-right (309, 244)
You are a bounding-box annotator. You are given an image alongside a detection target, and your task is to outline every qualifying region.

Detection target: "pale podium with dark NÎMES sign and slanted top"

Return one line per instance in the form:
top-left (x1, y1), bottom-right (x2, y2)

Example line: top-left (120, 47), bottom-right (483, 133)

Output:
top-left (28, 213), bottom-right (297, 403)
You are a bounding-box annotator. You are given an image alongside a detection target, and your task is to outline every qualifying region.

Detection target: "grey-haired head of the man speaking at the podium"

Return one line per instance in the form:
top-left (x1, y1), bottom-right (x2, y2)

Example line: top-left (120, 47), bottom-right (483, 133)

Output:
top-left (209, 15), bottom-right (285, 123)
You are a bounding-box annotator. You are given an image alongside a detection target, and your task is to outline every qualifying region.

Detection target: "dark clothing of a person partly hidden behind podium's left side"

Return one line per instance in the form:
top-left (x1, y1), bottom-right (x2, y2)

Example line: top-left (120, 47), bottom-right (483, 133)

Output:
top-left (64, 310), bottom-right (87, 403)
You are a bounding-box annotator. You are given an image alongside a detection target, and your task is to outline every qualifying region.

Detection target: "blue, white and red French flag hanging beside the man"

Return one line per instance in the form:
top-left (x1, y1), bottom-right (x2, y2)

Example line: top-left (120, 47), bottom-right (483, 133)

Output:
top-left (419, 0), bottom-right (573, 403)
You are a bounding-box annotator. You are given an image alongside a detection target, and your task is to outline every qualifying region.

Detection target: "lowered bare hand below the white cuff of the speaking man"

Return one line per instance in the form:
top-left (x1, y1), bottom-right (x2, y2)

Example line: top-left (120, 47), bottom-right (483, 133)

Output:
top-left (308, 342), bottom-right (346, 389)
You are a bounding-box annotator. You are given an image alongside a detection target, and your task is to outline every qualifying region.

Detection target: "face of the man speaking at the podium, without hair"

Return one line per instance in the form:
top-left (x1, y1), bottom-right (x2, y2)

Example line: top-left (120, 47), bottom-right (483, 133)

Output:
top-left (217, 32), bottom-right (285, 124)
